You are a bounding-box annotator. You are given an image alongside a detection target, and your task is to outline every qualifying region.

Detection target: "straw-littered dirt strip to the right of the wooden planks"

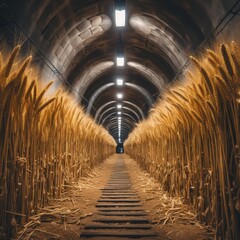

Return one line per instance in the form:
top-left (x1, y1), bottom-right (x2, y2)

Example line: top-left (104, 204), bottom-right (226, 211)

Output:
top-left (124, 155), bottom-right (214, 240)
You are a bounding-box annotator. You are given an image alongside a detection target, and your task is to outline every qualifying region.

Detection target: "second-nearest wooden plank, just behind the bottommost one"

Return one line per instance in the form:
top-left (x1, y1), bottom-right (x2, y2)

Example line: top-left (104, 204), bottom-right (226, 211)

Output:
top-left (84, 224), bottom-right (152, 230)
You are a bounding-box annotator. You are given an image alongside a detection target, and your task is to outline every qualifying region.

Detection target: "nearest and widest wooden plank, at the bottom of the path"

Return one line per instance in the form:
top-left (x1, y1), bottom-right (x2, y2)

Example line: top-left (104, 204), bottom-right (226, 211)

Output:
top-left (81, 231), bottom-right (158, 238)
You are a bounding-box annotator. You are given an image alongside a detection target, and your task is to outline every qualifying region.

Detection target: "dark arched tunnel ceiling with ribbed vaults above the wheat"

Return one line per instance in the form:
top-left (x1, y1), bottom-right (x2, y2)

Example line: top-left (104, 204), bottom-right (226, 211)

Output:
top-left (0, 0), bottom-right (236, 142)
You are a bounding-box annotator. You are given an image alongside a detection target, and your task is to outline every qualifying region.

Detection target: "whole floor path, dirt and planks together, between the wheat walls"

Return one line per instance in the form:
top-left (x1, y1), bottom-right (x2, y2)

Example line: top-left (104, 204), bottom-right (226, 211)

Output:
top-left (18, 154), bottom-right (213, 240)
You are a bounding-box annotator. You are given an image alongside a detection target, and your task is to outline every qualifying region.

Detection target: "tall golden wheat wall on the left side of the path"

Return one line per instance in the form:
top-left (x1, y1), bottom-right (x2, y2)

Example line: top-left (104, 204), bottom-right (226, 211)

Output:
top-left (0, 46), bottom-right (115, 237)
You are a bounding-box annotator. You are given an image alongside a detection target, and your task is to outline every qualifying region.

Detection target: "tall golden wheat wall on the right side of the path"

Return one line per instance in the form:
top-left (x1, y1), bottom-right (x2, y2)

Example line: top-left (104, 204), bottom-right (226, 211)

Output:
top-left (125, 42), bottom-right (240, 239)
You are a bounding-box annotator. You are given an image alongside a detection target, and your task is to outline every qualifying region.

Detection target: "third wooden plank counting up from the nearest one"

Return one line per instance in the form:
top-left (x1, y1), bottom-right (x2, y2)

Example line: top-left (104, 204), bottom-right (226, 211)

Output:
top-left (92, 216), bottom-right (149, 224)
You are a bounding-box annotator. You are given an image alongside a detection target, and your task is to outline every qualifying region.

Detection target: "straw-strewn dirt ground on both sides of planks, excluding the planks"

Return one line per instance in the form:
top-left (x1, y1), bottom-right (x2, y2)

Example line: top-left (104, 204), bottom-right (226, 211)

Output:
top-left (18, 155), bottom-right (213, 240)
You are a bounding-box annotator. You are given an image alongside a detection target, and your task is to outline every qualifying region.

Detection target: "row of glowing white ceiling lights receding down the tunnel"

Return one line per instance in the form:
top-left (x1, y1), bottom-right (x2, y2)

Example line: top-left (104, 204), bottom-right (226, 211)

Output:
top-left (115, 0), bottom-right (126, 143)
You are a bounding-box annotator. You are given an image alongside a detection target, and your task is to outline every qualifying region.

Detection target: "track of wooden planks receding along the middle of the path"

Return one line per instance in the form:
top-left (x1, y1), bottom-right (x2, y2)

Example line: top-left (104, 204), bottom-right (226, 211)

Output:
top-left (81, 155), bottom-right (158, 239)
